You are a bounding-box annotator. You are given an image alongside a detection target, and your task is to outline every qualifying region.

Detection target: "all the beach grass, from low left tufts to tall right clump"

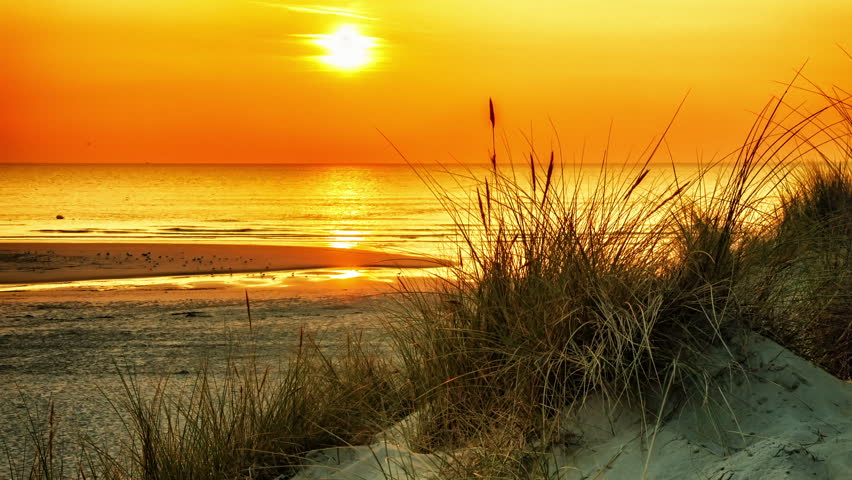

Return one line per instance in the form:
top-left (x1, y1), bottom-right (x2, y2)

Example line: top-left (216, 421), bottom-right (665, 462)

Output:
top-left (10, 72), bottom-right (852, 479)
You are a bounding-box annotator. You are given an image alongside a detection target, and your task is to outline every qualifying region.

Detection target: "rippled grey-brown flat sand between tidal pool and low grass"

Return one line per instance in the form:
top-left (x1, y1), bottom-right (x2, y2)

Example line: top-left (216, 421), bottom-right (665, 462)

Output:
top-left (0, 276), bottom-right (406, 479)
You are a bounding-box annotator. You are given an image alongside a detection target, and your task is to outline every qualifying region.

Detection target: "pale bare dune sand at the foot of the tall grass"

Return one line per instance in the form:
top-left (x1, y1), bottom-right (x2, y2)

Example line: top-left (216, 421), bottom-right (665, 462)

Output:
top-left (294, 336), bottom-right (852, 480)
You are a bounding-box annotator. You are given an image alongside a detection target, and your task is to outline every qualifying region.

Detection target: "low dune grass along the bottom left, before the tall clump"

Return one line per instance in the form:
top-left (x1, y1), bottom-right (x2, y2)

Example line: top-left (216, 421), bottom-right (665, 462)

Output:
top-left (10, 334), bottom-right (411, 479)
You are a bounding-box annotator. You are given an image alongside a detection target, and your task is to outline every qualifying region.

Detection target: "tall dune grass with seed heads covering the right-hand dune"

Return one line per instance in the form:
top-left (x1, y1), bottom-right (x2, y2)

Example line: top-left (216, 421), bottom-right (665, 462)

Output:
top-left (382, 75), bottom-right (850, 478)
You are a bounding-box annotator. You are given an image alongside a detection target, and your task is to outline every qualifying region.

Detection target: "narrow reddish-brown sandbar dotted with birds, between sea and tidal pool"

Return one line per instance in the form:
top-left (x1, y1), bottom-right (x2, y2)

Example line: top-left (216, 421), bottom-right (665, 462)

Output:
top-left (0, 242), bottom-right (446, 285)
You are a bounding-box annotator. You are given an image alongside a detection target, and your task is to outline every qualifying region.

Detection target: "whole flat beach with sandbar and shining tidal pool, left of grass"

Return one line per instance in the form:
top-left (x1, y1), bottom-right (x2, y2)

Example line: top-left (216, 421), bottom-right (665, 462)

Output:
top-left (0, 243), bottom-right (440, 470)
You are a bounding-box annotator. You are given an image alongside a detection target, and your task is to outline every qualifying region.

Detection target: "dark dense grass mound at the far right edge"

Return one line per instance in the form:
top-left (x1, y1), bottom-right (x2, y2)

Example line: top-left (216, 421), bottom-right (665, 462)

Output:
top-left (757, 163), bottom-right (852, 380)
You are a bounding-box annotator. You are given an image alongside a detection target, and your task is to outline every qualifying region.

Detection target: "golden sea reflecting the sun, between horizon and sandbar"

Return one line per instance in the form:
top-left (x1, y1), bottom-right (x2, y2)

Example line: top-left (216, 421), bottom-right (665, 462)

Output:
top-left (0, 164), bottom-right (744, 262)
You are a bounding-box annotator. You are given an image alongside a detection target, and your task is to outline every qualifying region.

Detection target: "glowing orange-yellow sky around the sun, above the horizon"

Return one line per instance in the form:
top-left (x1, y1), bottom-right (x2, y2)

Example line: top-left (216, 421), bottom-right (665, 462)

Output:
top-left (0, 0), bottom-right (852, 163)
